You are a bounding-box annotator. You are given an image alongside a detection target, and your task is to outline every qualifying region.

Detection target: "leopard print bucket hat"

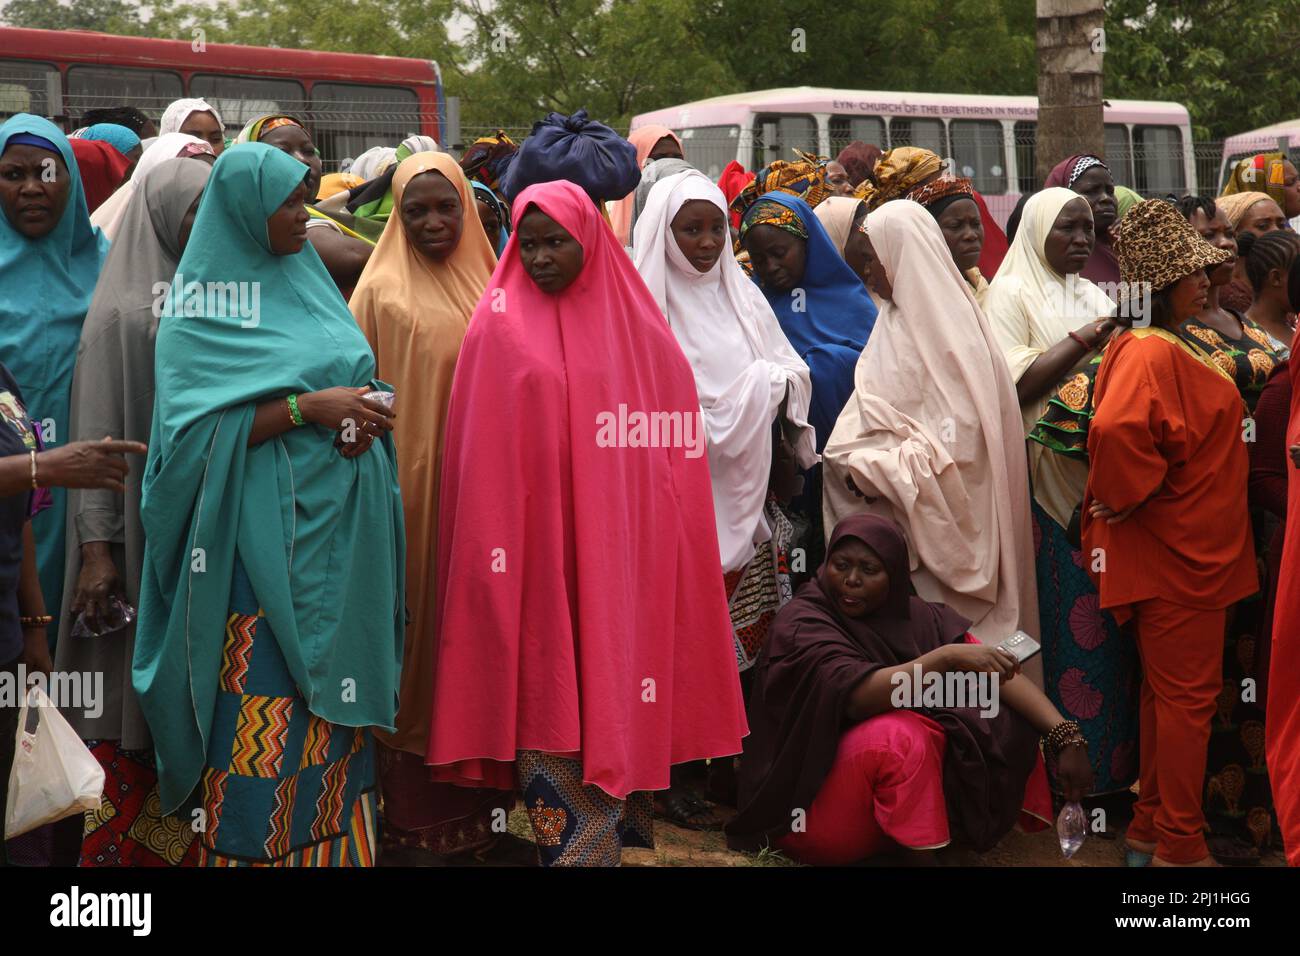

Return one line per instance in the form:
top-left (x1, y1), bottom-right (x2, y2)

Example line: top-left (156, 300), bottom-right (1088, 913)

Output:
top-left (1112, 199), bottom-right (1232, 293)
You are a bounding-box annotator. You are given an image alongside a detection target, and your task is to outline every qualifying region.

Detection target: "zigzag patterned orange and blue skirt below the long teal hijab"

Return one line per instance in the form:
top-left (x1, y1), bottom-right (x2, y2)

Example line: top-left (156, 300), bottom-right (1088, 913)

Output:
top-left (199, 561), bottom-right (377, 866)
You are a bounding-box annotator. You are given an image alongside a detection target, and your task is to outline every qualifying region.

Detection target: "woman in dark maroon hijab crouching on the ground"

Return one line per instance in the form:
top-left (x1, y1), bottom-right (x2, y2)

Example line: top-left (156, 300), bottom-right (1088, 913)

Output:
top-left (727, 515), bottom-right (1092, 864)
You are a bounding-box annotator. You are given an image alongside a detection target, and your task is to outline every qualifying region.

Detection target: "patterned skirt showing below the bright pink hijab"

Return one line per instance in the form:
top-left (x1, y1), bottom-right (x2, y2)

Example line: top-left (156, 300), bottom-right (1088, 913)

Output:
top-left (515, 750), bottom-right (654, 866)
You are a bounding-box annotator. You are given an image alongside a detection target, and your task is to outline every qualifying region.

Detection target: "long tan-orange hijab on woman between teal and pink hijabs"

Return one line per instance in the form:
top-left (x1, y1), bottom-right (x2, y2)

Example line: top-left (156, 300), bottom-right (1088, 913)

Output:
top-left (348, 152), bottom-right (497, 757)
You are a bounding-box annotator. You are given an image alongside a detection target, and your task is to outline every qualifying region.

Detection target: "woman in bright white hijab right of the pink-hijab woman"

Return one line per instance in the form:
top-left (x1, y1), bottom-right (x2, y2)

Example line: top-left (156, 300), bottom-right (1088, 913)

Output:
top-left (632, 169), bottom-right (818, 829)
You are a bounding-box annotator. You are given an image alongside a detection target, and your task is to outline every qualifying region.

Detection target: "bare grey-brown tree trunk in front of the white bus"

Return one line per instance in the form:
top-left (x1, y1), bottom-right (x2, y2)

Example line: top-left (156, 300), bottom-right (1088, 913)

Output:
top-left (1034, 0), bottom-right (1106, 185)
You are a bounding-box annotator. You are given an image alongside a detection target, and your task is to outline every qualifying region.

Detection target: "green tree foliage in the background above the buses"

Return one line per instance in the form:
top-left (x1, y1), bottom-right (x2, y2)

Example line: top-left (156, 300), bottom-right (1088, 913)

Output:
top-left (10, 0), bottom-right (1300, 139)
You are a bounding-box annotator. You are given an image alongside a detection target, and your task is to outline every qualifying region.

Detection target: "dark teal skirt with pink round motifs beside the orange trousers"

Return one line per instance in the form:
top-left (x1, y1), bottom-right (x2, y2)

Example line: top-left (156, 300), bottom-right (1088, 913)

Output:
top-left (1031, 501), bottom-right (1141, 795)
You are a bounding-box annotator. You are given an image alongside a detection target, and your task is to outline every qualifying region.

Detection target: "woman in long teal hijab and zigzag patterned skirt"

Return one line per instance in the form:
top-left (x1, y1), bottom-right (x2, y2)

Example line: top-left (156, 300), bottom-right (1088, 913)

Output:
top-left (133, 143), bottom-right (406, 866)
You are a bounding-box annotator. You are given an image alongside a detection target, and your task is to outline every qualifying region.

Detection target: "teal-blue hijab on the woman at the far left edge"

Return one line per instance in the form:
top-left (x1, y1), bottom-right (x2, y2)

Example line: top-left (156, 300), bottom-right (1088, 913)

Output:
top-left (0, 113), bottom-right (108, 647)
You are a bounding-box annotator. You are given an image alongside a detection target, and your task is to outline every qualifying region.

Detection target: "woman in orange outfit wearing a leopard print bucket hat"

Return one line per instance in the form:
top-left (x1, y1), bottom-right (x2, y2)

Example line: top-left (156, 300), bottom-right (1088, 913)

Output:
top-left (1083, 199), bottom-right (1258, 866)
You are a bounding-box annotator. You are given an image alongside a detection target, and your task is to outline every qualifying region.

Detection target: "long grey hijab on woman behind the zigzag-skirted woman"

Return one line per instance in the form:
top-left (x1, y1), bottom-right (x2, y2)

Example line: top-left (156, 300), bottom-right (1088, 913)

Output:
top-left (55, 157), bottom-right (212, 750)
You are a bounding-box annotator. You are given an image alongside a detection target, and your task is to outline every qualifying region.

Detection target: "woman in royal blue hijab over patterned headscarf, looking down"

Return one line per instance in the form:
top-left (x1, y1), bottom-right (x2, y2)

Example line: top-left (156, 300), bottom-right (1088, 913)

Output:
top-left (740, 191), bottom-right (876, 451)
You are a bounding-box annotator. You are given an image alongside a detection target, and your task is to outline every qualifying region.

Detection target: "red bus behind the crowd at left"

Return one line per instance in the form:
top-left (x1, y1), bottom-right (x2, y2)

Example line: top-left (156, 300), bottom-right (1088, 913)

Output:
top-left (0, 27), bottom-right (447, 168)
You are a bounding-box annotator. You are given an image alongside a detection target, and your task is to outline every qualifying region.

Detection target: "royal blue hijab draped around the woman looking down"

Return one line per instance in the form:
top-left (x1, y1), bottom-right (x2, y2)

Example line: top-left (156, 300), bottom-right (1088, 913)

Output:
top-left (754, 191), bottom-right (876, 451)
